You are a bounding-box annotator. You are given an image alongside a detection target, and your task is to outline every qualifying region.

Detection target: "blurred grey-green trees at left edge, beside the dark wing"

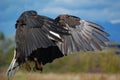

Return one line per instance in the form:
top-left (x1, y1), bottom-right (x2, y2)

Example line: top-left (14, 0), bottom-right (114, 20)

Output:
top-left (0, 32), bottom-right (15, 66)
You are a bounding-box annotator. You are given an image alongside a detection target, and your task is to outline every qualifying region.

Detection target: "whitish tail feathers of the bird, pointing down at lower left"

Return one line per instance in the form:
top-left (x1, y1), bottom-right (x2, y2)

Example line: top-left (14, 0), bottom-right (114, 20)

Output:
top-left (6, 50), bottom-right (19, 79)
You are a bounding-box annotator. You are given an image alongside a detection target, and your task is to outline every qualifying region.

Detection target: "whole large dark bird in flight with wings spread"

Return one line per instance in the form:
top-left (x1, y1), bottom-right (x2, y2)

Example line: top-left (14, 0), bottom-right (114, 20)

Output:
top-left (7, 11), bottom-right (108, 77)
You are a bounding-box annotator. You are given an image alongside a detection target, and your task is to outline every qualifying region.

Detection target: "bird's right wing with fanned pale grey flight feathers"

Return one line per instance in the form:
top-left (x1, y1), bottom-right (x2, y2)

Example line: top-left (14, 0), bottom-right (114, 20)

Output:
top-left (55, 15), bottom-right (109, 54)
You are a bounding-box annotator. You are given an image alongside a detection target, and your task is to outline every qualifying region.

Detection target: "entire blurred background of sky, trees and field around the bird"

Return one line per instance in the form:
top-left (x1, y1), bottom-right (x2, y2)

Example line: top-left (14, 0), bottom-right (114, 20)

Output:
top-left (0, 0), bottom-right (120, 80)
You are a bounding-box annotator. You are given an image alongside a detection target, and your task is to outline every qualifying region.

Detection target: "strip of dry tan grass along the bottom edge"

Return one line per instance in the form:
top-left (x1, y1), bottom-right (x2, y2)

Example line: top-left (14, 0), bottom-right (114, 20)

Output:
top-left (0, 71), bottom-right (120, 80)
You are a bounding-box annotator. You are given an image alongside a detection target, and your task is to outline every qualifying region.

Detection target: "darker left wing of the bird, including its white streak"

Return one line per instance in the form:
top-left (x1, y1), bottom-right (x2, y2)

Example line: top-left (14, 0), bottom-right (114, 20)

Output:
top-left (16, 11), bottom-right (68, 62)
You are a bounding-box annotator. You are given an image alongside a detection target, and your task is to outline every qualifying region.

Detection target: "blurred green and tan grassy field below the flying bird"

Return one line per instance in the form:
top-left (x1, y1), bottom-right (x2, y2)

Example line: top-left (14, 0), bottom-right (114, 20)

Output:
top-left (0, 51), bottom-right (120, 80)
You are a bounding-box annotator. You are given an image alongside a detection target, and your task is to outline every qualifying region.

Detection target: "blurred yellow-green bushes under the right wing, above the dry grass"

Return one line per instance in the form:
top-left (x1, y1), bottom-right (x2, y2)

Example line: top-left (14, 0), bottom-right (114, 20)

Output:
top-left (44, 50), bottom-right (120, 73)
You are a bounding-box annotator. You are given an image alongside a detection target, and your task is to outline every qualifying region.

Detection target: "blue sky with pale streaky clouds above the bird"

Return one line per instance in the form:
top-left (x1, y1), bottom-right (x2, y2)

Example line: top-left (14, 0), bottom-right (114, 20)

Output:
top-left (0, 0), bottom-right (120, 43)
